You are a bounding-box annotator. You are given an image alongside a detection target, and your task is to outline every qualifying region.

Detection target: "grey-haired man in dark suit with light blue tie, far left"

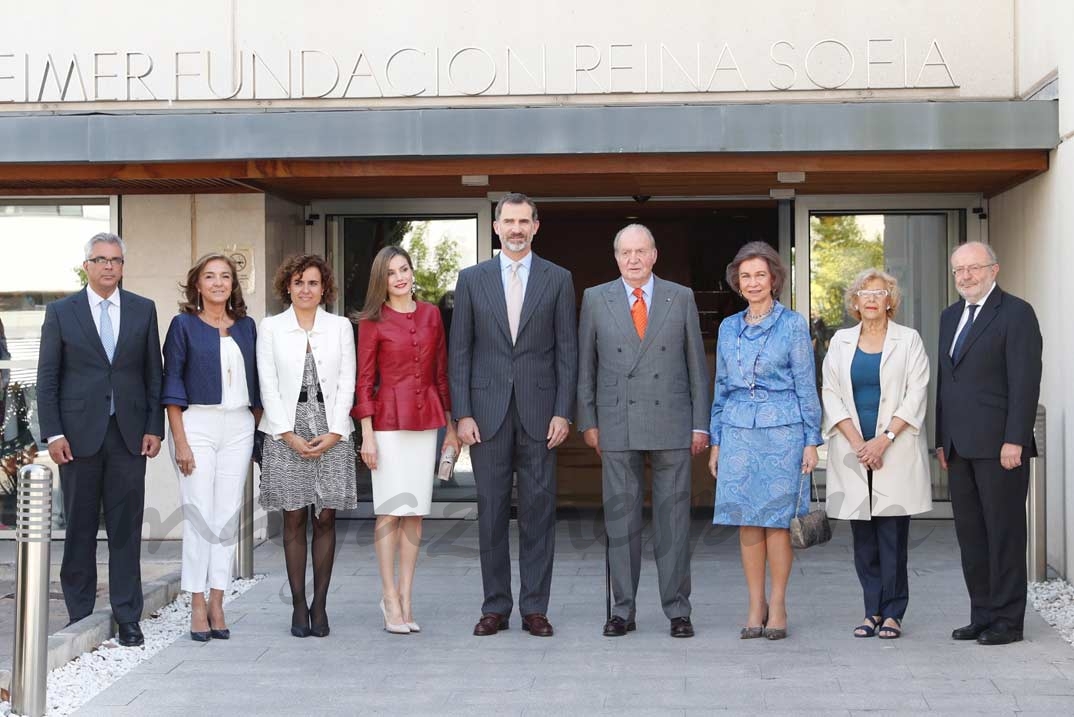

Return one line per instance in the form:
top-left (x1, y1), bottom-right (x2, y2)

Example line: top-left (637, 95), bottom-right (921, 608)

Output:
top-left (38, 234), bottom-right (164, 646)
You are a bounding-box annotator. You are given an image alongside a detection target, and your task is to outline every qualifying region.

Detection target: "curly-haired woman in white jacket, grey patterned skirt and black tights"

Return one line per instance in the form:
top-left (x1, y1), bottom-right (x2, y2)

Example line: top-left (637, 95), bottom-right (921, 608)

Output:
top-left (257, 254), bottom-right (358, 638)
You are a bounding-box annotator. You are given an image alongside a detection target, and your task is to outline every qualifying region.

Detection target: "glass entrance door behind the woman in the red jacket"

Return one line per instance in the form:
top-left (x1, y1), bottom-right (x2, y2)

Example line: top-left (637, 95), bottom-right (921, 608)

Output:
top-left (315, 202), bottom-right (491, 517)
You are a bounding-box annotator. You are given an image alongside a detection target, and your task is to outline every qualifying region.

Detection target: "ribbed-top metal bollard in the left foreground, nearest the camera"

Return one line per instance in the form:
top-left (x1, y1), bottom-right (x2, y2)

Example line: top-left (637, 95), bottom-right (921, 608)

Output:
top-left (11, 465), bottom-right (53, 717)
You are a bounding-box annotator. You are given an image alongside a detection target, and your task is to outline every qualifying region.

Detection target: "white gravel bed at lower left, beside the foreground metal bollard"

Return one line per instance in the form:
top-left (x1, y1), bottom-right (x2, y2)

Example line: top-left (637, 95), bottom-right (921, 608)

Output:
top-left (0, 575), bottom-right (264, 717)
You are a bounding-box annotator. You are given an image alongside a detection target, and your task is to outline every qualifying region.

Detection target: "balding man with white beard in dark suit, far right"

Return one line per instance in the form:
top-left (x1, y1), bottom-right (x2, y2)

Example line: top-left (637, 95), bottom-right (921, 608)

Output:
top-left (937, 242), bottom-right (1042, 645)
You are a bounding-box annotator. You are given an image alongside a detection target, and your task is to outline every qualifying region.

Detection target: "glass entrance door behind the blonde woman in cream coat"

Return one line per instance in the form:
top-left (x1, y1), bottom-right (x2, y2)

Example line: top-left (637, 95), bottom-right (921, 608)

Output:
top-left (796, 197), bottom-right (979, 516)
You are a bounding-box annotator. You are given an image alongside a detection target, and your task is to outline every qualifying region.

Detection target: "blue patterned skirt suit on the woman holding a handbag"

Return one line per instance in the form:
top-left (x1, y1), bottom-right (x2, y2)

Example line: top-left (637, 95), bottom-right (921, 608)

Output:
top-left (709, 302), bottom-right (824, 528)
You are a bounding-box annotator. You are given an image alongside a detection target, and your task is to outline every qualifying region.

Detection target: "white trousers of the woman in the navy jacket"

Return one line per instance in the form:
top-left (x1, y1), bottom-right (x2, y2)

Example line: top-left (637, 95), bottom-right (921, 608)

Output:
top-left (170, 406), bottom-right (253, 592)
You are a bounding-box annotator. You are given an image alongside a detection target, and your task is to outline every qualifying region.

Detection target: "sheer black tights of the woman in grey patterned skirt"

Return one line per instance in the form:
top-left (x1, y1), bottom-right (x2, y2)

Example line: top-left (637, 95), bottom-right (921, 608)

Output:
top-left (284, 507), bottom-right (335, 627)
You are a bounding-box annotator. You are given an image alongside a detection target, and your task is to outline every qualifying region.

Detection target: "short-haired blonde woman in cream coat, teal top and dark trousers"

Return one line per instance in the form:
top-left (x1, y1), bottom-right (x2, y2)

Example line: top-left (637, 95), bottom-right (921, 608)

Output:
top-left (822, 269), bottom-right (932, 639)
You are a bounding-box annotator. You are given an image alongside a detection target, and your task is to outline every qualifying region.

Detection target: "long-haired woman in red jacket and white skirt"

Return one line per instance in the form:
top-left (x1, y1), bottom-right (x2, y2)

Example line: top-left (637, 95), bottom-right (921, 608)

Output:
top-left (351, 246), bottom-right (461, 634)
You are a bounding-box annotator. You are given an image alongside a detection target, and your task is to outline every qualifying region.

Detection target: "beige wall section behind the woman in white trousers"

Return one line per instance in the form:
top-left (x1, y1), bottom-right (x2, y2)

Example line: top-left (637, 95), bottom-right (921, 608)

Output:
top-left (120, 194), bottom-right (266, 539)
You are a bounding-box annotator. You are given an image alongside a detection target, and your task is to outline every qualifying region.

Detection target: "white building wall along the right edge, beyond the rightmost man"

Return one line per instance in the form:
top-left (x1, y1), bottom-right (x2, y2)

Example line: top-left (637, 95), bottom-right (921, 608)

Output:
top-left (988, 0), bottom-right (1074, 576)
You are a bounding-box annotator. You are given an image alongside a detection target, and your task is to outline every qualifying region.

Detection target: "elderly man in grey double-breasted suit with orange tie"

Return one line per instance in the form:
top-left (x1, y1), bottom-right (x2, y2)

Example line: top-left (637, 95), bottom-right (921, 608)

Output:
top-left (578, 224), bottom-right (710, 638)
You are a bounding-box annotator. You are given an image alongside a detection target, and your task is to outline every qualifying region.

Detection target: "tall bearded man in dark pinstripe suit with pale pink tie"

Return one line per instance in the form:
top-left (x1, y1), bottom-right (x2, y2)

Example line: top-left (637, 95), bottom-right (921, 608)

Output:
top-left (448, 194), bottom-right (578, 636)
